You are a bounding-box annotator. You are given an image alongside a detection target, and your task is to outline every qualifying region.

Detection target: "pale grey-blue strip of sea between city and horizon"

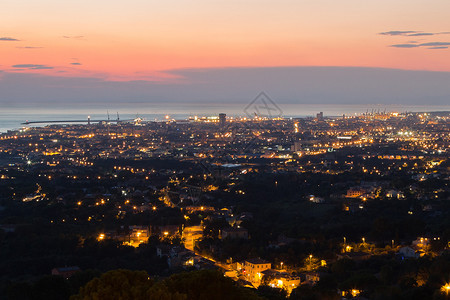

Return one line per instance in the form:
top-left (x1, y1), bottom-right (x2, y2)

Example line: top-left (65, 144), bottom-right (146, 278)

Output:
top-left (0, 103), bottom-right (450, 133)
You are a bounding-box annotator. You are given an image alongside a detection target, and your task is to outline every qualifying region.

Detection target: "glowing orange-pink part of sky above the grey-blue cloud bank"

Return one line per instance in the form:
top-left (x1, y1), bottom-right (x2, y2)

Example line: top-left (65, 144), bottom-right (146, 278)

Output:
top-left (0, 0), bottom-right (450, 106)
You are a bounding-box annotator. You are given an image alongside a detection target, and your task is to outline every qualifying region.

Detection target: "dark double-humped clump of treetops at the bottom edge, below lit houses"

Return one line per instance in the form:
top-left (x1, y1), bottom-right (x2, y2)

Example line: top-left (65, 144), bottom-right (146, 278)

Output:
top-left (71, 270), bottom-right (262, 300)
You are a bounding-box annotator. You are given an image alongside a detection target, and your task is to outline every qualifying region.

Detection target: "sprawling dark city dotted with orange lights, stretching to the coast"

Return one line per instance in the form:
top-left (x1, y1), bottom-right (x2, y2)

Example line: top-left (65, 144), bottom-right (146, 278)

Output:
top-left (0, 112), bottom-right (450, 298)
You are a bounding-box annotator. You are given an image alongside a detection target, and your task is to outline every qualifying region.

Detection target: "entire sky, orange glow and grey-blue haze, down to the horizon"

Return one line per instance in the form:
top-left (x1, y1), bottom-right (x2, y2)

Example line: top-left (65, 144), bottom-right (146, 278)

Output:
top-left (0, 0), bottom-right (450, 106)
